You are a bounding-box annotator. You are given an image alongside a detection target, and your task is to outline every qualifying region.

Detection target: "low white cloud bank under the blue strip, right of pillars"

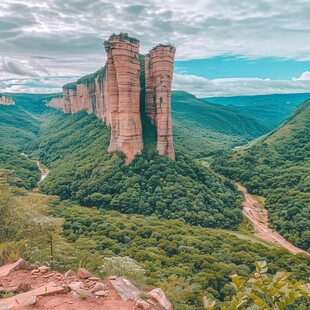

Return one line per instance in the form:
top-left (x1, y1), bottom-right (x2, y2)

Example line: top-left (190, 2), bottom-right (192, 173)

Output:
top-left (173, 74), bottom-right (310, 98)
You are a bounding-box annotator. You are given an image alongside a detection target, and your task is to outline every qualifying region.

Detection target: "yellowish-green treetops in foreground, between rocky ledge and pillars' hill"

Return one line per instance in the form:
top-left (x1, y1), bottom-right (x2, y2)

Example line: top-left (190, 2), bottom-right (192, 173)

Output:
top-left (51, 201), bottom-right (310, 310)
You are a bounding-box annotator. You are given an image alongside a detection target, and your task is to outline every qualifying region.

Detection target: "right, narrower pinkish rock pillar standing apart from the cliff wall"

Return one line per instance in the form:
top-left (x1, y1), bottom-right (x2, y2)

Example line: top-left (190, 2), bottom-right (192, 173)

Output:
top-left (145, 45), bottom-right (176, 159)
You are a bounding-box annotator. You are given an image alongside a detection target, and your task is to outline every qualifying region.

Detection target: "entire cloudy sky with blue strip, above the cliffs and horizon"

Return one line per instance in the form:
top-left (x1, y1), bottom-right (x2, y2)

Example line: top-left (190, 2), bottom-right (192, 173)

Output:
top-left (0, 0), bottom-right (310, 97)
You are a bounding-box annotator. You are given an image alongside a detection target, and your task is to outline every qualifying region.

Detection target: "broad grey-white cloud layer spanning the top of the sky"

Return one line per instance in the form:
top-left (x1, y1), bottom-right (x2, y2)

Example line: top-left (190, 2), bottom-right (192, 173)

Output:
top-left (0, 0), bottom-right (310, 73)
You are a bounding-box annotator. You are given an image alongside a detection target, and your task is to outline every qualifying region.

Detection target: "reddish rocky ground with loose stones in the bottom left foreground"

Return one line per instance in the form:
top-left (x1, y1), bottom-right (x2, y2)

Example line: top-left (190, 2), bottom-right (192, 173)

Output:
top-left (0, 259), bottom-right (173, 310)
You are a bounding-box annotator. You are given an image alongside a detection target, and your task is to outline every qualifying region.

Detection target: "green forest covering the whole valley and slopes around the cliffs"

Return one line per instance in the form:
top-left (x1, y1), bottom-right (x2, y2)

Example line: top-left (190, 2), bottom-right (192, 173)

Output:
top-left (0, 92), bottom-right (310, 310)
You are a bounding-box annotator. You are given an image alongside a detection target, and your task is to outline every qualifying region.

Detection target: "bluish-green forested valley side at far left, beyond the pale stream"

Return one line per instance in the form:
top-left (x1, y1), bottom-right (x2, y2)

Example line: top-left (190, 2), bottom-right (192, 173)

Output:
top-left (0, 94), bottom-right (57, 189)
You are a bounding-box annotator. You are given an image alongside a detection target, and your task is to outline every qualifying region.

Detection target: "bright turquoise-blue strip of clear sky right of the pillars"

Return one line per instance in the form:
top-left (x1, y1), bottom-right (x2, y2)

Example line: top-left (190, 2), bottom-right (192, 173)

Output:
top-left (175, 56), bottom-right (310, 80)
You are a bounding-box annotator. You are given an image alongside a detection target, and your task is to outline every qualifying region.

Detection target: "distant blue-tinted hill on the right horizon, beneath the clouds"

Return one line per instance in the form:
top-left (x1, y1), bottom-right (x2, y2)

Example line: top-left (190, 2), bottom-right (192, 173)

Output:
top-left (203, 93), bottom-right (310, 131)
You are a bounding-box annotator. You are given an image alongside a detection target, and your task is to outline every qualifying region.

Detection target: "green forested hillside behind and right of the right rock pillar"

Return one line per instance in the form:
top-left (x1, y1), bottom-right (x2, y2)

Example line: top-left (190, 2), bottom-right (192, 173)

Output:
top-left (172, 91), bottom-right (268, 158)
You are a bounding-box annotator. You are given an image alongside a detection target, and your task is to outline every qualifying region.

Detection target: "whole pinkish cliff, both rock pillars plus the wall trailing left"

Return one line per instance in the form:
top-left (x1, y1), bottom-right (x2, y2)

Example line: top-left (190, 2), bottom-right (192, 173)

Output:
top-left (49, 35), bottom-right (175, 163)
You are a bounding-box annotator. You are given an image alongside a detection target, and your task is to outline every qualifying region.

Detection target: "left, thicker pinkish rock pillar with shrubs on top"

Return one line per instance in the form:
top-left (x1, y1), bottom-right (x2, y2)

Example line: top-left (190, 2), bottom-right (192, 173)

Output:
top-left (105, 36), bottom-right (143, 162)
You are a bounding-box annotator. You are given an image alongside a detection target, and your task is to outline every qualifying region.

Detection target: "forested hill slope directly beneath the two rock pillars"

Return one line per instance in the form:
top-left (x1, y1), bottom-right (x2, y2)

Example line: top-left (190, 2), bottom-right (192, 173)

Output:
top-left (29, 112), bottom-right (242, 228)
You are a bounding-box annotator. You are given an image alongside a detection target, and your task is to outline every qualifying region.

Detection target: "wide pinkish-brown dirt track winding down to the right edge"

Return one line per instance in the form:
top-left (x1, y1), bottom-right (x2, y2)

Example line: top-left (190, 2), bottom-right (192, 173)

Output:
top-left (236, 183), bottom-right (310, 256)
